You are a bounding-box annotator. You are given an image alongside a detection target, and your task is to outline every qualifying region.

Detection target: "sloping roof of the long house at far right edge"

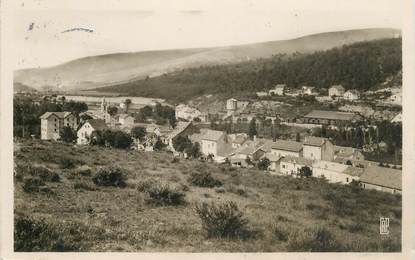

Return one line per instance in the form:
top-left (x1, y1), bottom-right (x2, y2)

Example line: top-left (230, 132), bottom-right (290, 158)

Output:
top-left (360, 166), bottom-right (402, 190)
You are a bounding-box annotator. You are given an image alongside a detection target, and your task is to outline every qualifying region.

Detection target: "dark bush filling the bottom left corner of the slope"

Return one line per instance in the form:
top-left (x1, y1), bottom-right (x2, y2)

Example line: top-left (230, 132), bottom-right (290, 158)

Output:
top-left (14, 216), bottom-right (78, 252)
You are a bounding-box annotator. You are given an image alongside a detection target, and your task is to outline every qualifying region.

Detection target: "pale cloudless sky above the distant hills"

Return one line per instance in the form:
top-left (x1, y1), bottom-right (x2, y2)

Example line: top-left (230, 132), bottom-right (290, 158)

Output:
top-left (12, 0), bottom-right (402, 69)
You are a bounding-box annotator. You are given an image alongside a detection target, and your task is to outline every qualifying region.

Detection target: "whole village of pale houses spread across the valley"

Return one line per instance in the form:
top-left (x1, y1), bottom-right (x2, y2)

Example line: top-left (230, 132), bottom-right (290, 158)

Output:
top-left (35, 81), bottom-right (402, 194)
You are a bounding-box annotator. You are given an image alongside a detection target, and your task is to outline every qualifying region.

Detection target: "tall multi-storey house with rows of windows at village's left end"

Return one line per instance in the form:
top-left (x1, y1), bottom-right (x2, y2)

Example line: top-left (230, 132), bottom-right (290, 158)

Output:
top-left (40, 112), bottom-right (78, 140)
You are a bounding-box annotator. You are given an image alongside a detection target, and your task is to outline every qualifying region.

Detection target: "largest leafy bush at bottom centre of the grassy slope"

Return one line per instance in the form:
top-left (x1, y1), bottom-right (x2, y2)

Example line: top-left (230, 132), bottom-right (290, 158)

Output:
top-left (195, 201), bottom-right (248, 238)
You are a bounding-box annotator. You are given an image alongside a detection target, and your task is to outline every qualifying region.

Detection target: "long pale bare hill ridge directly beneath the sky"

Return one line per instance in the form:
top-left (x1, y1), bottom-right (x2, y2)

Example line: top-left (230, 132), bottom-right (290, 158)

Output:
top-left (14, 29), bottom-right (400, 91)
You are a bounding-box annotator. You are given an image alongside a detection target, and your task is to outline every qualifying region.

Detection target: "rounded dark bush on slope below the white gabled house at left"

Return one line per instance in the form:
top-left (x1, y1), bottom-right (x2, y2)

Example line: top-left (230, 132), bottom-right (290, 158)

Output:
top-left (92, 167), bottom-right (127, 188)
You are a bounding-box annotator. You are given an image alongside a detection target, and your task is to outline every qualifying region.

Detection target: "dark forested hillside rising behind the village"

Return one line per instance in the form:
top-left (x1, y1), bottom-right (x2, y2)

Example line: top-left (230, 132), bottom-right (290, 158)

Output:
top-left (98, 38), bottom-right (402, 101)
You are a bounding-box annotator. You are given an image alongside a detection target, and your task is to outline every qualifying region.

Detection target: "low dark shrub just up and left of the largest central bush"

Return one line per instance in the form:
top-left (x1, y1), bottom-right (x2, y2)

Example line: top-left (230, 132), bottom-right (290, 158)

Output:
top-left (146, 183), bottom-right (185, 206)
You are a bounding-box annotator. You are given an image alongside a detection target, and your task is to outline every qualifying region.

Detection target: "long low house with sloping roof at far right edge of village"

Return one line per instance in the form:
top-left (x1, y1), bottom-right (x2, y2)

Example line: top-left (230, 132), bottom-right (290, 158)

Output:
top-left (360, 166), bottom-right (402, 194)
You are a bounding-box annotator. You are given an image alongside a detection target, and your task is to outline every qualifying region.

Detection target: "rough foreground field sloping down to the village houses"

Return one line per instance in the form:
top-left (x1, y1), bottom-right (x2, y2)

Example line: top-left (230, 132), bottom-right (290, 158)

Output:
top-left (14, 140), bottom-right (401, 252)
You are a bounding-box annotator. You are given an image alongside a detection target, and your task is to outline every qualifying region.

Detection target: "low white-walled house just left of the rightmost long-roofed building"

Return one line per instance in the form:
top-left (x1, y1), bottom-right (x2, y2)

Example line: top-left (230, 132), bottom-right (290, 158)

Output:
top-left (313, 160), bottom-right (363, 184)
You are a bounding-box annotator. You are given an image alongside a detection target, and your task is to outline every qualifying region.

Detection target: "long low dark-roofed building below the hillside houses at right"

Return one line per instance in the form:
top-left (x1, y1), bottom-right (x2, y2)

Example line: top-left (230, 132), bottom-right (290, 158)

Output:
top-left (303, 110), bottom-right (361, 125)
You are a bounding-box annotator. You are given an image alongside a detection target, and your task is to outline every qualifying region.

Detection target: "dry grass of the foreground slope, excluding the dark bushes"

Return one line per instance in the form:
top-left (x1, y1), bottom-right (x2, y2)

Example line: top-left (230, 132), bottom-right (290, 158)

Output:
top-left (15, 141), bottom-right (401, 252)
